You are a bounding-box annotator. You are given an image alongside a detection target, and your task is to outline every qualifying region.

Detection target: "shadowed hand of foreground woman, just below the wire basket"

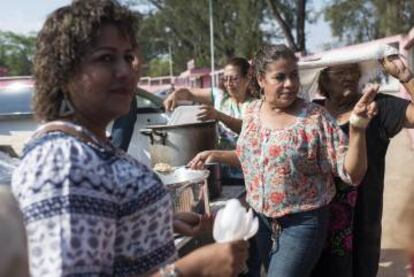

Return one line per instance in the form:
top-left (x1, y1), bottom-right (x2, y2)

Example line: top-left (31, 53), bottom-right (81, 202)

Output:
top-left (173, 212), bottom-right (214, 237)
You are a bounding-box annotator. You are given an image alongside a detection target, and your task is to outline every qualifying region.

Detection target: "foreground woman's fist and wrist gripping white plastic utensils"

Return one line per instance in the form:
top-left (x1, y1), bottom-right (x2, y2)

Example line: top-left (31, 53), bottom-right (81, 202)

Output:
top-left (190, 241), bottom-right (248, 277)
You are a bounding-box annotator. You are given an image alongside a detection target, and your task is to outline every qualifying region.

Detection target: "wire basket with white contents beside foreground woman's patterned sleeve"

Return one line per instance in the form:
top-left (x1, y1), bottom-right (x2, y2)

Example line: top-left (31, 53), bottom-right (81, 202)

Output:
top-left (157, 167), bottom-right (210, 214)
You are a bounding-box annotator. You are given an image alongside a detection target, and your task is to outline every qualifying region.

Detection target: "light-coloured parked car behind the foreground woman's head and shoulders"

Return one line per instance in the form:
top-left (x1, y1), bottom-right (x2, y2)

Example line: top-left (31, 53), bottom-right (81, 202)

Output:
top-left (0, 77), bottom-right (168, 165)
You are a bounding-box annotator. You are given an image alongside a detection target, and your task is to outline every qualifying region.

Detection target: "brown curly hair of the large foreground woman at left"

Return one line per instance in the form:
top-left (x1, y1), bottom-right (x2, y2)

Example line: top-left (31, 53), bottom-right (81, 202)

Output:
top-left (33, 0), bottom-right (138, 121)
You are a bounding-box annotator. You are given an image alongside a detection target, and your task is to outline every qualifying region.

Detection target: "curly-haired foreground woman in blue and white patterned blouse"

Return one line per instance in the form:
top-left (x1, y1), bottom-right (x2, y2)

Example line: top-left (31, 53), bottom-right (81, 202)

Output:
top-left (12, 0), bottom-right (247, 277)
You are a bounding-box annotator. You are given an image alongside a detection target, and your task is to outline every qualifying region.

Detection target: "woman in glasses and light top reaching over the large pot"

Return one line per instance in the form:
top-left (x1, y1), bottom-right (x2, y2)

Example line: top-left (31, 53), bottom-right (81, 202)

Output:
top-left (164, 57), bottom-right (254, 185)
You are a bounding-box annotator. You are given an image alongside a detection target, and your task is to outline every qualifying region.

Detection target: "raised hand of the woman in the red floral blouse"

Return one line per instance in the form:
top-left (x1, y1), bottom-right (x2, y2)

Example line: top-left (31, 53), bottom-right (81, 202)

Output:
top-left (350, 84), bottom-right (379, 127)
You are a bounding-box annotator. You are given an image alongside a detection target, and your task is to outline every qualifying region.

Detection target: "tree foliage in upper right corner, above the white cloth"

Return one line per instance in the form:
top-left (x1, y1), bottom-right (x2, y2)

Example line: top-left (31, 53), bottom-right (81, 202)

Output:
top-left (325, 0), bottom-right (414, 44)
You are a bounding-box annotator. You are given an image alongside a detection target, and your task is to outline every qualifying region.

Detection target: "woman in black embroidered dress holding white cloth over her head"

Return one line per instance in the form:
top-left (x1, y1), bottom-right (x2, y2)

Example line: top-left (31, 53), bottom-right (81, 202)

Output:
top-left (313, 52), bottom-right (414, 277)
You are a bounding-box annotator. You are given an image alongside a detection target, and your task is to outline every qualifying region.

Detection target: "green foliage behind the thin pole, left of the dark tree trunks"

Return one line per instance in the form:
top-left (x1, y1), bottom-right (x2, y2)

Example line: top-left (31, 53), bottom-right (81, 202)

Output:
top-left (128, 0), bottom-right (275, 74)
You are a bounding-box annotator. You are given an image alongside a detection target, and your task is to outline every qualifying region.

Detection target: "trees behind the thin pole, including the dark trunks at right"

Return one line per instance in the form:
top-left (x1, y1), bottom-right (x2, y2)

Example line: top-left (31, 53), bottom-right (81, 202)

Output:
top-left (127, 0), bottom-right (311, 73)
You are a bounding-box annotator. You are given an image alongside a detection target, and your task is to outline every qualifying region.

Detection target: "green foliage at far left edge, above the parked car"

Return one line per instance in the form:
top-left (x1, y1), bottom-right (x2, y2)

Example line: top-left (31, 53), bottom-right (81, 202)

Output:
top-left (0, 31), bottom-right (35, 76)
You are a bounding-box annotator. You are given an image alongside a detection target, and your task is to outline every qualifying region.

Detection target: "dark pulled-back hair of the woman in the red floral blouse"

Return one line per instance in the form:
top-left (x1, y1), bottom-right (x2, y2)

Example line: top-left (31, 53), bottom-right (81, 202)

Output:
top-left (250, 44), bottom-right (298, 97)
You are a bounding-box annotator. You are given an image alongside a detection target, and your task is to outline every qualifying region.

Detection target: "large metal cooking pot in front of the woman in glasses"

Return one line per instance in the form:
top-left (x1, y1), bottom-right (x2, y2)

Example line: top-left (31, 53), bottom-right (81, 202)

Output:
top-left (141, 121), bottom-right (217, 166)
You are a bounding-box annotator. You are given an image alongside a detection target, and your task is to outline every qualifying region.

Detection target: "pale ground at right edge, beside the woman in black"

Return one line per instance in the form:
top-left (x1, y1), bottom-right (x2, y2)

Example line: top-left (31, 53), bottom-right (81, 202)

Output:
top-left (378, 131), bottom-right (414, 277)
